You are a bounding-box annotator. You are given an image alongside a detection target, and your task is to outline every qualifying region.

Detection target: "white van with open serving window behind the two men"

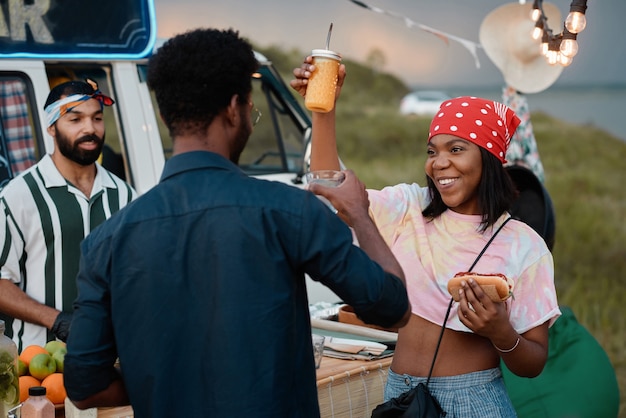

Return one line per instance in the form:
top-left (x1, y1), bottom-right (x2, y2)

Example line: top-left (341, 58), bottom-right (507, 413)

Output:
top-left (0, 37), bottom-right (311, 194)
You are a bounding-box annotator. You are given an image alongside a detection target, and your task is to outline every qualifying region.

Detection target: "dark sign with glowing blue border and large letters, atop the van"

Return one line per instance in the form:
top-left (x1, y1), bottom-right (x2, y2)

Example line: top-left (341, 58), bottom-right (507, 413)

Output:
top-left (0, 0), bottom-right (156, 59)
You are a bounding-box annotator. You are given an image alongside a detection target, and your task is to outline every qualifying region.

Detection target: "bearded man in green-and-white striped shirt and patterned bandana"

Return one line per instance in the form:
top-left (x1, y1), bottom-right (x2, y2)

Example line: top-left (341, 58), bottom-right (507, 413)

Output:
top-left (0, 80), bottom-right (136, 352)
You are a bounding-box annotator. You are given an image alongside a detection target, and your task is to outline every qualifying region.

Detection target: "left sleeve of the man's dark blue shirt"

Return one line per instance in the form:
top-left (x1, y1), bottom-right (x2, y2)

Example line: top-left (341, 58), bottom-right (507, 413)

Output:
top-left (64, 236), bottom-right (120, 400)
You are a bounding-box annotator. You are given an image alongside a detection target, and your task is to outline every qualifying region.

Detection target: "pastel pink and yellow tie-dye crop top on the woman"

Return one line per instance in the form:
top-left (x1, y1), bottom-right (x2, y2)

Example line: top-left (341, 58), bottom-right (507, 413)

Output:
top-left (368, 184), bottom-right (561, 334)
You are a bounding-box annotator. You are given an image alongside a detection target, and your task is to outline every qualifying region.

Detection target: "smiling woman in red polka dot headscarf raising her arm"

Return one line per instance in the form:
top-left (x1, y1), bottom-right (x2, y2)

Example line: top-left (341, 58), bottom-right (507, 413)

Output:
top-left (291, 57), bottom-right (560, 418)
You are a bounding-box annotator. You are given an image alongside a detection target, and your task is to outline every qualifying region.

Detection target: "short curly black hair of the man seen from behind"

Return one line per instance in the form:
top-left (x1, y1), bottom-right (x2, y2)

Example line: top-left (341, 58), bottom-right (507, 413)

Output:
top-left (147, 29), bottom-right (258, 137)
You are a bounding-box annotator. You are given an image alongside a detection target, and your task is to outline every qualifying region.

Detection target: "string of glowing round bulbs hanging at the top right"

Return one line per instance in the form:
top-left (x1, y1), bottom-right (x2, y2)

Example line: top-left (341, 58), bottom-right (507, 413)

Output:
top-left (530, 0), bottom-right (587, 67)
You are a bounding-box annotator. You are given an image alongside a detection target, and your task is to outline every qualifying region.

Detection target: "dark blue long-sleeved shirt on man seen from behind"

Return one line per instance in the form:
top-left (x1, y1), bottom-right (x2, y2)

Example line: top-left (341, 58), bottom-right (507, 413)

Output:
top-left (65, 152), bottom-right (408, 418)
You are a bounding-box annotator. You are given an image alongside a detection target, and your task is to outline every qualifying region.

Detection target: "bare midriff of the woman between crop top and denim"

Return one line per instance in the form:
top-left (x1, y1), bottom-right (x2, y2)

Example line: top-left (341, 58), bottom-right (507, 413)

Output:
top-left (391, 315), bottom-right (500, 377)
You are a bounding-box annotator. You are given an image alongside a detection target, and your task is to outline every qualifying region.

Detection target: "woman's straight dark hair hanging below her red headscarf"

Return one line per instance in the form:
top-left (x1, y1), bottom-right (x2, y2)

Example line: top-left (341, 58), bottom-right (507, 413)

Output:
top-left (422, 148), bottom-right (517, 232)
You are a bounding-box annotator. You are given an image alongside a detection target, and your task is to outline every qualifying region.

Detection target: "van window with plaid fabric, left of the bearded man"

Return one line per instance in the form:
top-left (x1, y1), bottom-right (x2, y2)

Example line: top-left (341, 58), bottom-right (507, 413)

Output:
top-left (0, 73), bottom-right (43, 187)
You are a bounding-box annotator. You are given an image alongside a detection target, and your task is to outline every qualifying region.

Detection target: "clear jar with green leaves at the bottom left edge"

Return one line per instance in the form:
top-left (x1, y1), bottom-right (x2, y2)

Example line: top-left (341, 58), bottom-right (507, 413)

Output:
top-left (0, 320), bottom-right (20, 418)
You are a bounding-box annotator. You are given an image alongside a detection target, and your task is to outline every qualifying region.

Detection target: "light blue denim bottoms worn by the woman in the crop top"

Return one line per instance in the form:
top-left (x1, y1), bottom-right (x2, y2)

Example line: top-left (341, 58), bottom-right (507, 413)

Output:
top-left (385, 368), bottom-right (517, 418)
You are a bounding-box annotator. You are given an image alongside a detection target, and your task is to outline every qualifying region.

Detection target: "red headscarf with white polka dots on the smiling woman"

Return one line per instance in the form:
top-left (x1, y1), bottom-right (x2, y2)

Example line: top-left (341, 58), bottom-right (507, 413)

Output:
top-left (428, 96), bottom-right (520, 164)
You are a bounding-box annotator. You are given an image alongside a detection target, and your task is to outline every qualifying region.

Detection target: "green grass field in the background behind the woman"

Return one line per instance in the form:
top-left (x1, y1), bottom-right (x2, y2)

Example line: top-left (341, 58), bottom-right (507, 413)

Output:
top-left (338, 109), bottom-right (626, 417)
